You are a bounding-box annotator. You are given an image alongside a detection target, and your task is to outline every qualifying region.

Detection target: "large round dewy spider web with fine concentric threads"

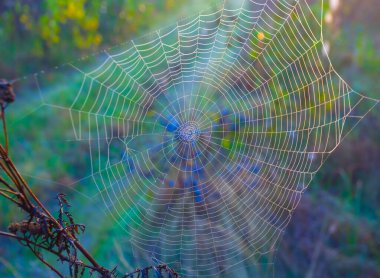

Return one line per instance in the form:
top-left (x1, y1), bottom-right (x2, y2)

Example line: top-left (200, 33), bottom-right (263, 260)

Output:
top-left (8, 0), bottom-right (377, 277)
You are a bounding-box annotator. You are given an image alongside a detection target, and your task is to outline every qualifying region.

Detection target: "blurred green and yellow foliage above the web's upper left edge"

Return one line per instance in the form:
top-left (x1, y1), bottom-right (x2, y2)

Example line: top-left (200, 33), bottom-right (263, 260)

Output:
top-left (0, 0), bottom-right (193, 77)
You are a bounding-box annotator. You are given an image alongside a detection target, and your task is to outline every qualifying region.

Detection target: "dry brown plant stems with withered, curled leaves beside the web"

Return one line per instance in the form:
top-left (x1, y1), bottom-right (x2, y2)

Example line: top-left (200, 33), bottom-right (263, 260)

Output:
top-left (0, 80), bottom-right (179, 278)
